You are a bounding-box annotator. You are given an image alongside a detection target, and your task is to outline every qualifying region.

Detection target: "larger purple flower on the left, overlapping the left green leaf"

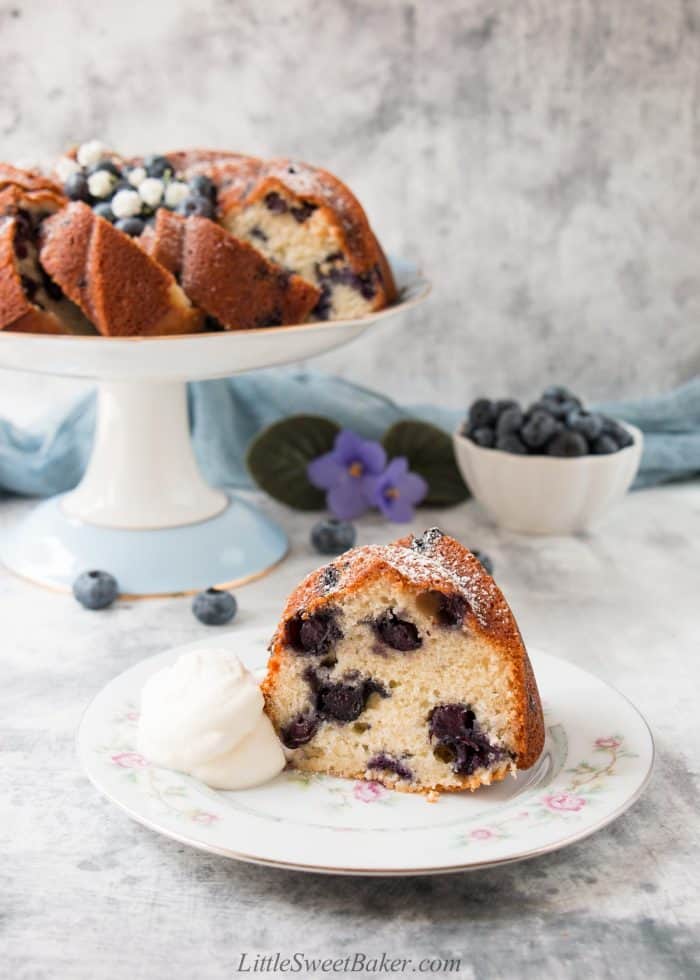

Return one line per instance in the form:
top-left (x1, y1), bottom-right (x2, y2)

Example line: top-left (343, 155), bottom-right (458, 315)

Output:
top-left (307, 429), bottom-right (386, 521)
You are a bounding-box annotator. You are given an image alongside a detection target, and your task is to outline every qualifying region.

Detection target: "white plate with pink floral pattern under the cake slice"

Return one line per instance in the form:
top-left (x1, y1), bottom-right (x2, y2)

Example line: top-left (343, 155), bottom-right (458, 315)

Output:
top-left (78, 629), bottom-right (654, 875)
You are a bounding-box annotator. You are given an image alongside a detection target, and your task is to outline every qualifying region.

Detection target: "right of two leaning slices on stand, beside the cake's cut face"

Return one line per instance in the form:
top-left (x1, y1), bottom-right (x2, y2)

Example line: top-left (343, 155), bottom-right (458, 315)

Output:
top-left (138, 208), bottom-right (319, 330)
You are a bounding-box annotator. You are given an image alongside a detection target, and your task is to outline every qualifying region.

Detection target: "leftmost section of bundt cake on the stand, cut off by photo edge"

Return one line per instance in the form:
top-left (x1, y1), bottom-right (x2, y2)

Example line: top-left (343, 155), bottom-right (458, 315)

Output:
top-left (0, 166), bottom-right (95, 334)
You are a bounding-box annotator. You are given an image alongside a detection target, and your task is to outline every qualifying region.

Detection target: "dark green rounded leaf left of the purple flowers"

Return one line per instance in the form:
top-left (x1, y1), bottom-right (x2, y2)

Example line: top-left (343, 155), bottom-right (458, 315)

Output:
top-left (246, 415), bottom-right (340, 510)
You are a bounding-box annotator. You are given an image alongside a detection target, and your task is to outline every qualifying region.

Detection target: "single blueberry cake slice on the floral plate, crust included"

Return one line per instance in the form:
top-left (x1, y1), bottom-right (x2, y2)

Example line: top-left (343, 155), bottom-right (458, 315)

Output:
top-left (263, 528), bottom-right (544, 793)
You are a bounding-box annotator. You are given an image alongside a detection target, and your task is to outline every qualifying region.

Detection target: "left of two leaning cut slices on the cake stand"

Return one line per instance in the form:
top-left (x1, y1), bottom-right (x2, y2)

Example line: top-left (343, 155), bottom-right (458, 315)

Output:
top-left (39, 201), bottom-right (203, 337)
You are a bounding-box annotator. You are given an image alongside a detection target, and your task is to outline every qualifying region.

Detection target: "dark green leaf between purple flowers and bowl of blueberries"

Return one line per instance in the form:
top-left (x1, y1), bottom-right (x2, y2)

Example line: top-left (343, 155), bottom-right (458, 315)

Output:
top-left (382, 419), bottom-right (469, 507)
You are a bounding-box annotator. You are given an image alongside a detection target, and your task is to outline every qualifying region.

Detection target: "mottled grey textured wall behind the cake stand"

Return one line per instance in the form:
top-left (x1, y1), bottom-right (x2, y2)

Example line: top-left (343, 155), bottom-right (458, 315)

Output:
top-left (0, 0), bottom-right (700, 418)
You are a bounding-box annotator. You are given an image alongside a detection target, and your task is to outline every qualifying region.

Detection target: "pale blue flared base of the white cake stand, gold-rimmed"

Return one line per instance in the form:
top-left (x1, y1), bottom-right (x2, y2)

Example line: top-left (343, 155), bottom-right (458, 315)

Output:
top-left (0, 496), bottom-right (288, 597)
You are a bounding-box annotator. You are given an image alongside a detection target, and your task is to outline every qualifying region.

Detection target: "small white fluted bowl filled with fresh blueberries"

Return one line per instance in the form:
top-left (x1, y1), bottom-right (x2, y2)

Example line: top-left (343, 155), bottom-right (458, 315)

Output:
top-left (454, 385), bottom-right (642, 534)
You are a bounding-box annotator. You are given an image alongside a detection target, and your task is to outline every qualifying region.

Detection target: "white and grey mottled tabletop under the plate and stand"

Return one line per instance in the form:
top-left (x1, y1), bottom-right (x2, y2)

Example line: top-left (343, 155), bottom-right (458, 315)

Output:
top-left (0, 483), bottom-right (700, 980)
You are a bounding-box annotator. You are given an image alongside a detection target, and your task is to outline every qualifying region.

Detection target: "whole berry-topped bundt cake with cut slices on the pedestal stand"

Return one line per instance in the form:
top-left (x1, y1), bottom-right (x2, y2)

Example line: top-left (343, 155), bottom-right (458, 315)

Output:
top-left (0, 140), bottom-right (396, 337)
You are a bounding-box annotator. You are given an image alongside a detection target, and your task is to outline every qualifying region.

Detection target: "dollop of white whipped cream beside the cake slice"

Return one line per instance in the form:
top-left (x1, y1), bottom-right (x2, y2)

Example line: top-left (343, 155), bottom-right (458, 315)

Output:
top-left (138, 649), bottom-right (286, 789)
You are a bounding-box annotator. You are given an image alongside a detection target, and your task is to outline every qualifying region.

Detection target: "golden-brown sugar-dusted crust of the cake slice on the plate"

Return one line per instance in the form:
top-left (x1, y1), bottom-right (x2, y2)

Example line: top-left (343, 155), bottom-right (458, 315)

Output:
top-left (262, 528), bottom-right (545, 792)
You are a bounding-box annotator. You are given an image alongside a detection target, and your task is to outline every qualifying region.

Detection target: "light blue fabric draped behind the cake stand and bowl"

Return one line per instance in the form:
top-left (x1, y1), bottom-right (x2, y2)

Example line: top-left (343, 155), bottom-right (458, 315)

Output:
top-left (0, 368), bottom-right (700, 496)
